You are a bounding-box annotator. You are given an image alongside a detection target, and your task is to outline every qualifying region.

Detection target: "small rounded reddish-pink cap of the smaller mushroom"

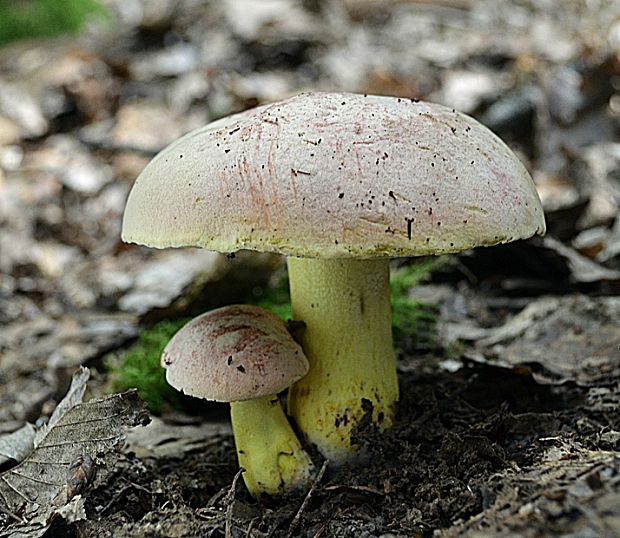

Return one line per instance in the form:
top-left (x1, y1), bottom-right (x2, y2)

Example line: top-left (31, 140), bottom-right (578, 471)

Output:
top-left (161, 305), bottom-right (308, 402)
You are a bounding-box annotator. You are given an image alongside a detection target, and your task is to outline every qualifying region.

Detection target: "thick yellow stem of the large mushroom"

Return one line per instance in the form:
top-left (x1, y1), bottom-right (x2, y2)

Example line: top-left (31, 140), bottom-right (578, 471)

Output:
top-left (288, 257), bottom-right (398, 464)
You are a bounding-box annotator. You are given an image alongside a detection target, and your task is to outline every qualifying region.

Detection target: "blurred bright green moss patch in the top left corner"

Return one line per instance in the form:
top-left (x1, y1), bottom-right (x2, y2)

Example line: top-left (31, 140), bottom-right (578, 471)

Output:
top-left (0, 0), bottom-right (107, 45)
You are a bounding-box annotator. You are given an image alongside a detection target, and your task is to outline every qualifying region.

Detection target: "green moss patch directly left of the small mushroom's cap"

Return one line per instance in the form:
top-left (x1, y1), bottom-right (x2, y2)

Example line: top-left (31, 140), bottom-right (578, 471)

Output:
top-left (108, 319), bottom-right (189, 413)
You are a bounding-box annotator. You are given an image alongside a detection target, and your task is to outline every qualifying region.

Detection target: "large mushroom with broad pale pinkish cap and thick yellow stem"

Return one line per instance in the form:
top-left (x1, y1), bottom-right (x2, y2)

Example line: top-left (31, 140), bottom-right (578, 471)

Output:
top-left (123, 93), bottom-right (545, 463)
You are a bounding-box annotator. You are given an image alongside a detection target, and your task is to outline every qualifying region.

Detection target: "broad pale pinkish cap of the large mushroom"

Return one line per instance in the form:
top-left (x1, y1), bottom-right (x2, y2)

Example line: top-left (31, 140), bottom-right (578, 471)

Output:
top-left (122, 93), bottom-right (545, 258)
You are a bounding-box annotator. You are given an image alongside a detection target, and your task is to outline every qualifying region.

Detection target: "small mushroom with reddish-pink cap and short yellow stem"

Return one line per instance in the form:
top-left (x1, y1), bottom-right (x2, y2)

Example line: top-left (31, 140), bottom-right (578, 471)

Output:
top-left (161, 305), bottom-right (314, 497)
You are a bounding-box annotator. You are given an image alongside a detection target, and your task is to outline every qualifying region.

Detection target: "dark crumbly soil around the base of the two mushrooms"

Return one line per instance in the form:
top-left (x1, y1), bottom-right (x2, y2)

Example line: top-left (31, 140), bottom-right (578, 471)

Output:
top-left (51, 356), bottom-right (620, 537)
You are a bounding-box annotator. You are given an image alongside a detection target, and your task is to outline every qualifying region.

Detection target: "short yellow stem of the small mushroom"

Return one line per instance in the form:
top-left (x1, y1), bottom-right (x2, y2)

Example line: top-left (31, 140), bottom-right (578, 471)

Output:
top-left (230, 395), bottom-right (314, 498)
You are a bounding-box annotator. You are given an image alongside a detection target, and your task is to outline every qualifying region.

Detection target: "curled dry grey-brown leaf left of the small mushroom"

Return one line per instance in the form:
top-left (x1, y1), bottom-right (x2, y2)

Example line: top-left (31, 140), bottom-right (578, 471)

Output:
top-left (0, 368), bottom-right (149, 537)
